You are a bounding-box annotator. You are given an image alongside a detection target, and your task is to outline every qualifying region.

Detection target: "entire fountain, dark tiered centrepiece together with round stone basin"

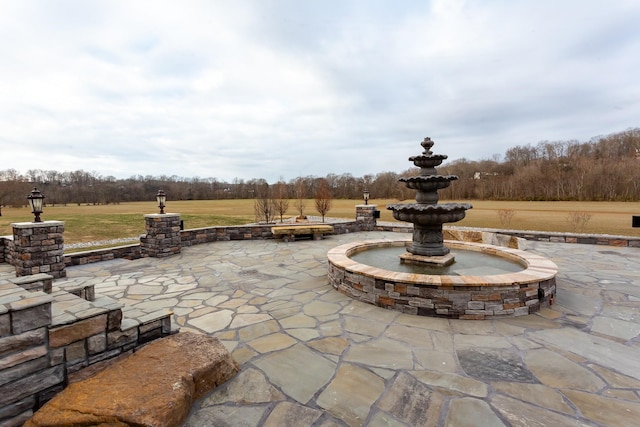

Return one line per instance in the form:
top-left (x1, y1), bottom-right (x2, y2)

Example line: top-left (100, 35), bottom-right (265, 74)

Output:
top-left (327, 138), bottom-right (557, 319)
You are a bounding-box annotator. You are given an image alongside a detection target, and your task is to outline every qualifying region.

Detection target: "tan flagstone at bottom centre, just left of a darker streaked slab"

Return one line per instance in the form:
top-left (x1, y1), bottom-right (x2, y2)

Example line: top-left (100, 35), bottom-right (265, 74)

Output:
top-left (317, 363), bottom-right (384, 426)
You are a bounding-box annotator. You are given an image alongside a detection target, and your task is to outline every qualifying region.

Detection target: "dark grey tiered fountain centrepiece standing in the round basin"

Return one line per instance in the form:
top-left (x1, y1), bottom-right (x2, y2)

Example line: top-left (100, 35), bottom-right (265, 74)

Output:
top-left (387, 137), bottom-right (472, 266)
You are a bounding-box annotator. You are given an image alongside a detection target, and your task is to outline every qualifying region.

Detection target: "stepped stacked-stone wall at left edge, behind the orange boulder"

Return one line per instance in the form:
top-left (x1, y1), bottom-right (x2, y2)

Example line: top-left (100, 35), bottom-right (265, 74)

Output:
top-left (0, 273), bottom-right (172, 426)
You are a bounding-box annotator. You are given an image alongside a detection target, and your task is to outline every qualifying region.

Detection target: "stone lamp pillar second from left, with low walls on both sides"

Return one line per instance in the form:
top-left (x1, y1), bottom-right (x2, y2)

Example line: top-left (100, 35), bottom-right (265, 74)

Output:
top-left (140, 214), bottom-right (182, 258)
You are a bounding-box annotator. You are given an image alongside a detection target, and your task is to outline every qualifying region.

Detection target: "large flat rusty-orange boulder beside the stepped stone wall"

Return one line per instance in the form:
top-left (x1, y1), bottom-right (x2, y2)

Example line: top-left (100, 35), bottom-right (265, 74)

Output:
top-left (25, 332), bottom-right (240, 427)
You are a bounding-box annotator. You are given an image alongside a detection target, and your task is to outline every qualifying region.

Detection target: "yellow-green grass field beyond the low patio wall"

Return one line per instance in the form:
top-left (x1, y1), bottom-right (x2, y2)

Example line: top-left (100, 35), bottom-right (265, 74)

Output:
top-left (0, 200), bottom-right (640, 243)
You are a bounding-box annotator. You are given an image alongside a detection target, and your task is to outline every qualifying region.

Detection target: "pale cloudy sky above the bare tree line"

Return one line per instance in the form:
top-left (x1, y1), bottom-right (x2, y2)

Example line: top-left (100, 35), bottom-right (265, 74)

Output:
top-left (0, 0), bottom-right (640, 182)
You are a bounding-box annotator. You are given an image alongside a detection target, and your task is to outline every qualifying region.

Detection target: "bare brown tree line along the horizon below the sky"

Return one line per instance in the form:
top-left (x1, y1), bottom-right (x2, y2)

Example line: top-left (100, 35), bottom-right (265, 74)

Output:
top-left (0, 128), bottom-right (640, 211)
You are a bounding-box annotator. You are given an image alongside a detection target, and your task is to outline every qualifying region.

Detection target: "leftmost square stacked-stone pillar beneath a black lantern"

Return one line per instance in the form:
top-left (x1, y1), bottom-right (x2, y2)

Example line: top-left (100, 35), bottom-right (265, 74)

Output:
top-left (11, 221), bottom-right (67, 279)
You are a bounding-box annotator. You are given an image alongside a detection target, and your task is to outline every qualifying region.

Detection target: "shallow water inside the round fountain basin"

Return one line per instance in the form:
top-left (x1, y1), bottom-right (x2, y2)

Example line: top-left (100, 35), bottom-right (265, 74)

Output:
top-left (350, 246), bottom-right (524, 276)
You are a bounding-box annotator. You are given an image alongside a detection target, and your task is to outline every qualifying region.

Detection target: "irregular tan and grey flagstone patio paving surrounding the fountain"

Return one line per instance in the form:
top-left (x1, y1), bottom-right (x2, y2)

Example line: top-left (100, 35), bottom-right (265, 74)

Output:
top-left (12, 232), bottom-right (640, 427)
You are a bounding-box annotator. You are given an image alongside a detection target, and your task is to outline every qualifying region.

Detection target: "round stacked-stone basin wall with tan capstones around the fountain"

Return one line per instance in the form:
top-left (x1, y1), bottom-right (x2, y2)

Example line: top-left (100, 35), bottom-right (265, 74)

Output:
top-left (327, 239), bottom-right (558, 320)
